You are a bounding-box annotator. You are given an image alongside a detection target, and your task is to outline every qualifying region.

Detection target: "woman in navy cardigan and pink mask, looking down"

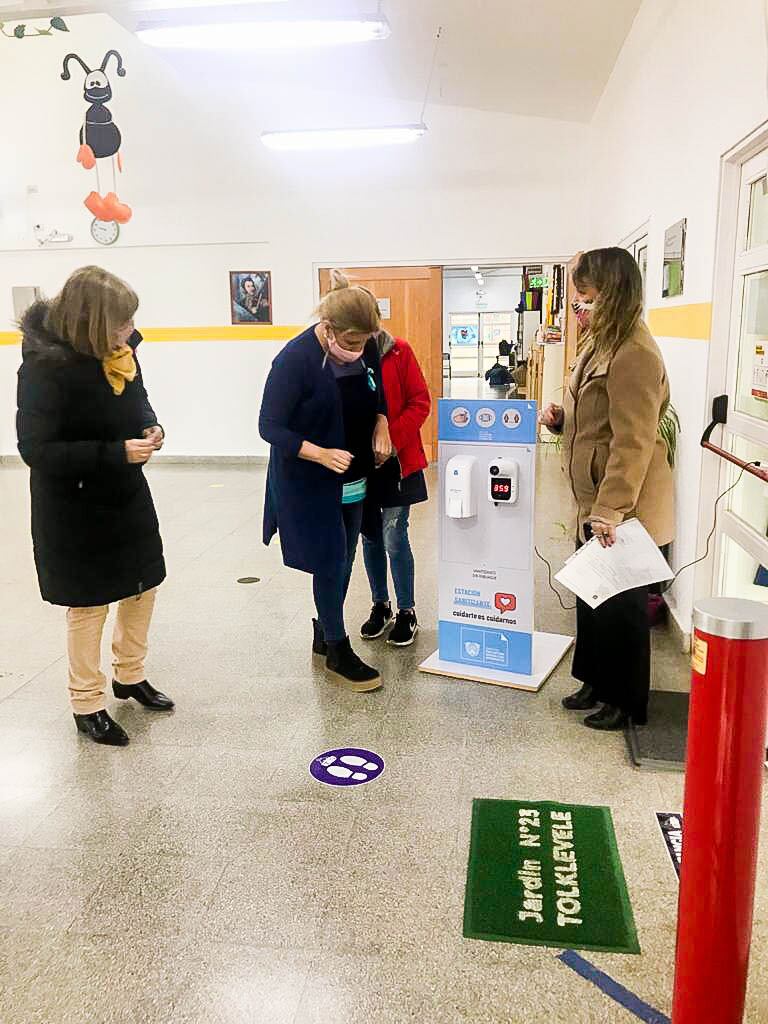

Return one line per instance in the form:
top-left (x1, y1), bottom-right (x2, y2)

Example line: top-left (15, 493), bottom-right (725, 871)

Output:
top-left (259, 271), bottom-right (391, 691)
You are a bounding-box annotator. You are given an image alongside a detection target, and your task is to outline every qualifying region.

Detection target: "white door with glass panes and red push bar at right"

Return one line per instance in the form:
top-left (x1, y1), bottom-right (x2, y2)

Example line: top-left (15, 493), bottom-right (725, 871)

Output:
top-left (715, 151), bottom-right (768, 603)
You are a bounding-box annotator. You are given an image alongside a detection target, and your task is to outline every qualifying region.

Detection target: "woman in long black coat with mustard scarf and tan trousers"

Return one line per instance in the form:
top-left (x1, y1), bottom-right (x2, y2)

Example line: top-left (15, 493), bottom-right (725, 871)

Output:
top-left (16, 266), bottom-right (173, 746)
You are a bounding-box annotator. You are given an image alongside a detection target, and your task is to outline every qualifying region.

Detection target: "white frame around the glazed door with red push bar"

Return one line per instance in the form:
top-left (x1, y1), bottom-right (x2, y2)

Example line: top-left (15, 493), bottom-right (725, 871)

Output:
top-left (693, 121), bottom-right (768, 602)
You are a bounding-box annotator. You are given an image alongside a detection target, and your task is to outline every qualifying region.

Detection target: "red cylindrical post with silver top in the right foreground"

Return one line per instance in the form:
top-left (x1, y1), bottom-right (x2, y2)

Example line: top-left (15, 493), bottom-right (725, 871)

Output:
top-left (672, 598), bottom-right (768, 1024)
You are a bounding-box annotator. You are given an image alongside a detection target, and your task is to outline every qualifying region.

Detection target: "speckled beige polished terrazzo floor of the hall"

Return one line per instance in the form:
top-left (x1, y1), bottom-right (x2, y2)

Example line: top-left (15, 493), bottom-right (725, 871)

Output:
top-left (0, 451), bottom-right (768, 1024)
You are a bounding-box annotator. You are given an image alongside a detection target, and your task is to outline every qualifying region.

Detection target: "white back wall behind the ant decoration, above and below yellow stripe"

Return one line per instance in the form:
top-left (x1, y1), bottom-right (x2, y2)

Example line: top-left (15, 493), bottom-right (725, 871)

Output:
top-left (0, 15), bottom-right (586, 455)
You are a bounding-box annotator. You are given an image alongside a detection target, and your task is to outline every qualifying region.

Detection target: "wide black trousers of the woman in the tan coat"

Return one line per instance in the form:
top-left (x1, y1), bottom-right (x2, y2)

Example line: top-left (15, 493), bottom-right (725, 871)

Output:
top-left (572, 526), bottom-right (650, 725)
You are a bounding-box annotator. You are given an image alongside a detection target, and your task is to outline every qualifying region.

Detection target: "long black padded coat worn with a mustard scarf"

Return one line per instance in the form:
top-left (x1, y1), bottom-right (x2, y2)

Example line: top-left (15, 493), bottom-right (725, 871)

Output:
top-left (16, 302), bottom-right (165, 607)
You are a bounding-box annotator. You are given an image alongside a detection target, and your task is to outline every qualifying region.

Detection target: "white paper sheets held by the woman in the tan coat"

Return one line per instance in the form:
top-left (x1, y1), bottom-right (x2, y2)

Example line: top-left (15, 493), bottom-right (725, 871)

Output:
top-left (555, 519), bottom-right (675, 608)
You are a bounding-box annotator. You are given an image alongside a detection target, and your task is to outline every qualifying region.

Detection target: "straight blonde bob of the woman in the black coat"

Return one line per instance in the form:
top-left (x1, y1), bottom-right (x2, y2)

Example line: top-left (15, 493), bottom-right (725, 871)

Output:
top-left (45, 266), bottom-right (138, 359)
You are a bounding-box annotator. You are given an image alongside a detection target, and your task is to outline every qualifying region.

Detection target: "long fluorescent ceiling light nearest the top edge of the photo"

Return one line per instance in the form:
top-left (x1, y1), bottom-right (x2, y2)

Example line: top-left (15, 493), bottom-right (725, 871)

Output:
top-left (136, 17), bottom-right (390, 50)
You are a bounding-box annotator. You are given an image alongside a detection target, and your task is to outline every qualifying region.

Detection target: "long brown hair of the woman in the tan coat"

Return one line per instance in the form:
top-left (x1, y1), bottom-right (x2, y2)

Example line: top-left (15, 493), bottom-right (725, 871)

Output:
top-left (573, 247), bottom-right (643, 357)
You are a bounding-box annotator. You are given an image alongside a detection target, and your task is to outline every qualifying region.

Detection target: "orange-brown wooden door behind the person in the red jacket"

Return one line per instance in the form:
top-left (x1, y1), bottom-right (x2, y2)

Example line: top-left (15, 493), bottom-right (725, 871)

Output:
top-left (319, 266), bottom-right (442, 462)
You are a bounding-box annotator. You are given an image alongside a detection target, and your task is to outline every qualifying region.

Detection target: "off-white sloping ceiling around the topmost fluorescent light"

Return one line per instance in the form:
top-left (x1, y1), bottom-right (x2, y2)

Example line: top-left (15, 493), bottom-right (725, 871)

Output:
top-left (0, 0), bottom-right (642, 121)
